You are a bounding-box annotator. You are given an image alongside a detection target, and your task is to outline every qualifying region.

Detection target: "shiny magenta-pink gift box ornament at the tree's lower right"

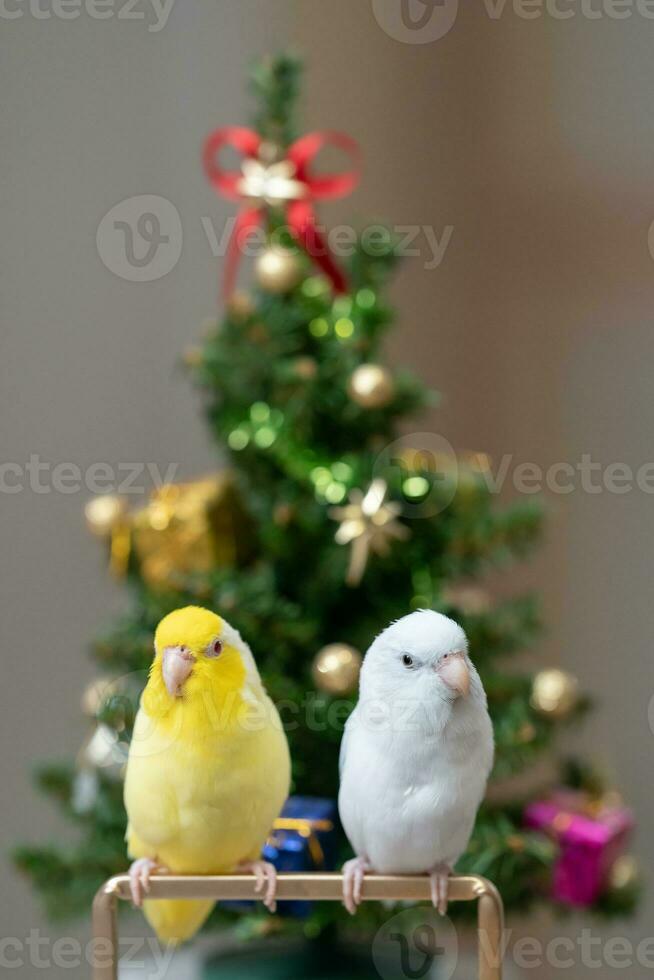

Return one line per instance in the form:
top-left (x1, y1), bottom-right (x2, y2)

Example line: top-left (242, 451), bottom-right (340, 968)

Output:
top-left (525, 791), bottom-right (634, 906)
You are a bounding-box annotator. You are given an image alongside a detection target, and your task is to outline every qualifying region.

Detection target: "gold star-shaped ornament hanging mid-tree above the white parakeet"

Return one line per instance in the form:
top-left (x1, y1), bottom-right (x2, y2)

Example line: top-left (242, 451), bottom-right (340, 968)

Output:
top-left (329, 479), bottom-right (411, 585)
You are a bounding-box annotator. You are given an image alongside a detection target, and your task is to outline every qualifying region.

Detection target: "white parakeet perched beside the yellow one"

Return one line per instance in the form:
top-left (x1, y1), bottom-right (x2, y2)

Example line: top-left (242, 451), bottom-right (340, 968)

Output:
top-left (338, 610), bottom-right (493, 914)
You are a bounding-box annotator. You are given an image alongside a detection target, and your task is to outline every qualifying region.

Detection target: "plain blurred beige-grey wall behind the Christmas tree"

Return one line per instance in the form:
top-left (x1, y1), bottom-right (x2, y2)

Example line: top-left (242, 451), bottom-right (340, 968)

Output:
top-left (0, 0), bottom-right (654, 978)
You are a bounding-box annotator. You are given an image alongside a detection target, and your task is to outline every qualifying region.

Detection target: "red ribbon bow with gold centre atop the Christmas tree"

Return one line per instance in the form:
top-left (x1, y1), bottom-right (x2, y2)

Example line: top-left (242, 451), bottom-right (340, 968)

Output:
top-left (203, 126), bottom-right (359, 298)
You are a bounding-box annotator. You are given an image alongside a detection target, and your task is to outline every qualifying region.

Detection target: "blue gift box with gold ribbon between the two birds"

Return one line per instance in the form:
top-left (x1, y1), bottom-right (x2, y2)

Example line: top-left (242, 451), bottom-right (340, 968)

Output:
top-left (225, 796), bottom-right (337, 918)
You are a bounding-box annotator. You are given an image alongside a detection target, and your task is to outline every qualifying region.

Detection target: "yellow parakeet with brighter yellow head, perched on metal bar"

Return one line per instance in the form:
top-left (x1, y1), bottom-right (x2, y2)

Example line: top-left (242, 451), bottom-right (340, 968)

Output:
top-left (125, 606), bottom-right (290, 943)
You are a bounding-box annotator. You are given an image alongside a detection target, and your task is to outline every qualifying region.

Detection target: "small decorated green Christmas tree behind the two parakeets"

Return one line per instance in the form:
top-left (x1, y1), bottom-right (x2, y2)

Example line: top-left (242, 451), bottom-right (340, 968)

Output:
top-left (16, 56), bottom-right (635, 935)
